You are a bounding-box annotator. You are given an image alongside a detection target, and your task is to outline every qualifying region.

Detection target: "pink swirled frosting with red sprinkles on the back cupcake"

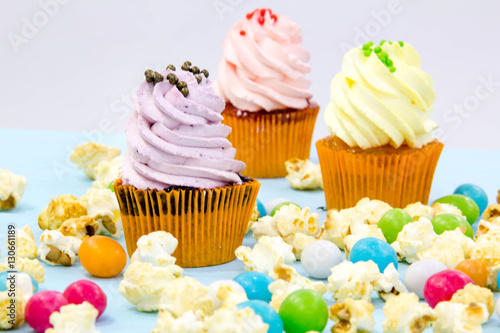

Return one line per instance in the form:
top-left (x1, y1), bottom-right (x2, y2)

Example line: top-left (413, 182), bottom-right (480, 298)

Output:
top-left (214, 9), bottom-right (312, 111)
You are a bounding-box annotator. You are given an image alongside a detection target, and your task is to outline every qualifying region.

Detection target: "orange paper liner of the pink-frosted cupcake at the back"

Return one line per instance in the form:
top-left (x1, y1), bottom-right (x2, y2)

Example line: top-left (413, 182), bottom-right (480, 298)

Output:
top-left (222, 103), bottom-right (319, 178)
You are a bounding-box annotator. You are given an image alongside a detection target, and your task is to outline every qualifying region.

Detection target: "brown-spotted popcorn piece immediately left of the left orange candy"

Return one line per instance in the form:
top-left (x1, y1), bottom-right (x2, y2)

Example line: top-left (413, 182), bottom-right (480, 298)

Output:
top-left (37, 230), bottom-right (82, 266)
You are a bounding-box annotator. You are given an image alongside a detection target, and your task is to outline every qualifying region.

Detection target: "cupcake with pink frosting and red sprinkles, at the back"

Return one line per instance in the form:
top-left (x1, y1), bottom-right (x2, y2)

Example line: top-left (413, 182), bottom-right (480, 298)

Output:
top-left (215, 9), bottom-right (319, 178)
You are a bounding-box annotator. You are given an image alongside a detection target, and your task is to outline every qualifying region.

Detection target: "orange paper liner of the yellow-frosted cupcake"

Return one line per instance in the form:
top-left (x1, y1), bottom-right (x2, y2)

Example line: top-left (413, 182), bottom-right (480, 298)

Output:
top-left (316, 136), bottom-right (443, 209)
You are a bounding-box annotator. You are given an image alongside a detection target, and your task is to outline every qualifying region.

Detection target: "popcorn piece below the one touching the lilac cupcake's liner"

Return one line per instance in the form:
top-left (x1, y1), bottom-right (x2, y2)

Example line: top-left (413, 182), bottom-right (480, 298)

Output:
top-left (118, 261), bottom-right (183, 312)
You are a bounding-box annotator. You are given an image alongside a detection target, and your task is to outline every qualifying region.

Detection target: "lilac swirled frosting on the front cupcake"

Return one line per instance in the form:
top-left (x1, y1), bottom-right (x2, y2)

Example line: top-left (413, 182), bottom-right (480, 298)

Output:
top-left (122, 69), bottom-right (245, 190)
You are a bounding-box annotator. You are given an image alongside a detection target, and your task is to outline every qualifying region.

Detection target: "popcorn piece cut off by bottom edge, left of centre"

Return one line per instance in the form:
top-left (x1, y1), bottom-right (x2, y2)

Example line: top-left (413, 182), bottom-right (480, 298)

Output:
top-left (152, 311), bottom-right (206, 333)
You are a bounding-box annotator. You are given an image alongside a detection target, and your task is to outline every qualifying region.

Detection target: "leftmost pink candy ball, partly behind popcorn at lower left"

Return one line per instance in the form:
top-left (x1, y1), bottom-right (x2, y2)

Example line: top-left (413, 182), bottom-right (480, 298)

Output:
top-left (24, 291), bottom-right (68, 332)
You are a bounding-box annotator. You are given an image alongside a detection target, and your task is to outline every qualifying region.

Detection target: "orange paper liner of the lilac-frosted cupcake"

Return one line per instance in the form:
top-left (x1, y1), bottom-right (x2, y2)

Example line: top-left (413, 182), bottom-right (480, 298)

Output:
top-left (114, 179), bottom-right (260, 267)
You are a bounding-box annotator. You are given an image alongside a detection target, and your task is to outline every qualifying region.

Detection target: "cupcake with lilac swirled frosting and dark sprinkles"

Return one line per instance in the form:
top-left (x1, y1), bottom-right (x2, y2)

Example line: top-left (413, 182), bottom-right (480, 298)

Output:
top-left (115, 62), bottom-right (260, 267)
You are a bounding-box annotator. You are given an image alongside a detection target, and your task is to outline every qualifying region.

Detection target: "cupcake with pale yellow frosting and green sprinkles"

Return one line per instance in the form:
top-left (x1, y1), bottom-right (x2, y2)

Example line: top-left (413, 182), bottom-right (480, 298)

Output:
top-left (316, 41), bottom-right (443, 209)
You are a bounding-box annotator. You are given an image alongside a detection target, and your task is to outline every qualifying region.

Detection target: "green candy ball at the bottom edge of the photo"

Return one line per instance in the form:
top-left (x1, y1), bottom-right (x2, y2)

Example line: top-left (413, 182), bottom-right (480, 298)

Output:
top-left (279, 289), bottom-right (328, 333)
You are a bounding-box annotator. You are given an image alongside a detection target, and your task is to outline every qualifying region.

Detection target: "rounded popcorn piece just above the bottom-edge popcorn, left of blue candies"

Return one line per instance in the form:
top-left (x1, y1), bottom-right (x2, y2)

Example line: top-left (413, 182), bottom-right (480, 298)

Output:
top-left (159, 276), bottom-right (212, 318)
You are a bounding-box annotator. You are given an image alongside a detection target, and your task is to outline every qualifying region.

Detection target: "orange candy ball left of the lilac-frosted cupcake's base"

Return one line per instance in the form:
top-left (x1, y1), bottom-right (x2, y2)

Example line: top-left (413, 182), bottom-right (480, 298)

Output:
top-left (78, 236), bottom-right (127, 278)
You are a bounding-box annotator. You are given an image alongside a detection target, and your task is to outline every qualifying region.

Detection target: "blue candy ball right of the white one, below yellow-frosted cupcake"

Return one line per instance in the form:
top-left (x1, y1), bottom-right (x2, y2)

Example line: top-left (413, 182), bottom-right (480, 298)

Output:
top-left (349, 237), bottom-right (398, 272)
